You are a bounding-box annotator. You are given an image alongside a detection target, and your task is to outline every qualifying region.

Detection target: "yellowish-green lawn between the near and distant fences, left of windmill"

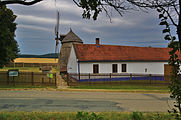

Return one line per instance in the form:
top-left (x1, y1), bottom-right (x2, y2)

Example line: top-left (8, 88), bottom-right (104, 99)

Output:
top-left (0, 67), bottom-right (58, 73)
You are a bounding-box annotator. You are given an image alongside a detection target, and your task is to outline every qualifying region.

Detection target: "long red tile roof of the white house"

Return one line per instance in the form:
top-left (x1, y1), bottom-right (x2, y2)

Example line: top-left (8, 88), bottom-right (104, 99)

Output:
top-left (74, 44), bottom-right (181, 61)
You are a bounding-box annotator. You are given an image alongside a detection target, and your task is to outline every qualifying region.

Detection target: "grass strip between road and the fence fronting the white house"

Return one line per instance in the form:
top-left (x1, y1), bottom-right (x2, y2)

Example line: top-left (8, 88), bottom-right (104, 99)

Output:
top-left (71, 85), bottom-right (169, 91)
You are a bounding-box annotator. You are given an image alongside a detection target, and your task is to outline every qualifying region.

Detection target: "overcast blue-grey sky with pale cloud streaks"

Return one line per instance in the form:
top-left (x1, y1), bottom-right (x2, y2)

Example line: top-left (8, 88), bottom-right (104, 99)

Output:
top-left (8, 0), bottom-right (168, 54)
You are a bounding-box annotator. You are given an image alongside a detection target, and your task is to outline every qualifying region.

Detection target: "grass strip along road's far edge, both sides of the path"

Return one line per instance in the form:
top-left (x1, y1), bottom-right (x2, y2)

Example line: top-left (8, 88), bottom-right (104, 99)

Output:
top-left (0, 85), bottom-right (169, 93)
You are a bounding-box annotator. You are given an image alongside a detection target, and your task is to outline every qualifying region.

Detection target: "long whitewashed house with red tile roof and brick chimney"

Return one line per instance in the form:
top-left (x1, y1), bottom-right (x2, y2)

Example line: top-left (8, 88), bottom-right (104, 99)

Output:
top-left (67, 38), bottom-right (172, 74)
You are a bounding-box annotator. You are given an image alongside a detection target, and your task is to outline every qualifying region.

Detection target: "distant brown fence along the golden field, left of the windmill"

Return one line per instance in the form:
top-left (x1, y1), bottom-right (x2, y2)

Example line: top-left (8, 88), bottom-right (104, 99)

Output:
top-left (5, 63), bottom-right (57, 67)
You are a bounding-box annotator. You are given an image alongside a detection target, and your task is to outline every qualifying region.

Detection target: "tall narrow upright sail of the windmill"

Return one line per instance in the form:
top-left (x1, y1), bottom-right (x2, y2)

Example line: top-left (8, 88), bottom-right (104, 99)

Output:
top-left (55, 11), bottom-right (60, 53)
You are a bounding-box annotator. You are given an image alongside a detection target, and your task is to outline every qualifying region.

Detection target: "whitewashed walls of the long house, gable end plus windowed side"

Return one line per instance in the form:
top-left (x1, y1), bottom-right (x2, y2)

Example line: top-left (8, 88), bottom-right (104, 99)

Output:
top-left (67, 46), bottom-right (168, 74)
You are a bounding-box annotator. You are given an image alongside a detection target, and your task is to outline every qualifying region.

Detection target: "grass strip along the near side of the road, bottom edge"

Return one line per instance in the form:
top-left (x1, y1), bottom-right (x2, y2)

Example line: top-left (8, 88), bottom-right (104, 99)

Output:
top-left (0, 112), bottom-right (174, 120)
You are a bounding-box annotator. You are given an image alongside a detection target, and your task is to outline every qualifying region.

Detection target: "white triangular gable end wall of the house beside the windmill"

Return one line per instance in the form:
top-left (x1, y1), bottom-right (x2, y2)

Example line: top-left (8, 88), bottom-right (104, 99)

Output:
top-left (67, 45), bottom-right (78, 73)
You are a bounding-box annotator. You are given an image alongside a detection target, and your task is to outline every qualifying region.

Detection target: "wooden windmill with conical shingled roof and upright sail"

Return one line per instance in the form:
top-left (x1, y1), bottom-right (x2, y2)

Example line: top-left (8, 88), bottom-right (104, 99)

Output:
top-left (55, 11), bottom-right (83, 73)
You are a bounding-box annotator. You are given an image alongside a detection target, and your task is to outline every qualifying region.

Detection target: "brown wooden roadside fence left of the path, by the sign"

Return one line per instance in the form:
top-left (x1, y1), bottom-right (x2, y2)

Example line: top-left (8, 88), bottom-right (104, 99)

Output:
top-left (0, 71), bottom-right (57, 86)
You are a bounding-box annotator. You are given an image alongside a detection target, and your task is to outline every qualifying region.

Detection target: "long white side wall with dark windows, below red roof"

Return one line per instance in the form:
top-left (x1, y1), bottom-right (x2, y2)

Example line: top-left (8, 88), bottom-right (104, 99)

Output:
top-left (80, 62), bottom-right (168, 74)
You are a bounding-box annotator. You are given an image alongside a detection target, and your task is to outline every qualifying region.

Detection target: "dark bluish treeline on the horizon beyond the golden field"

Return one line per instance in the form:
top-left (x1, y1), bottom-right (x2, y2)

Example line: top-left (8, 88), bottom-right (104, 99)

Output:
top-left (18, 53), bottom-right (59, 58)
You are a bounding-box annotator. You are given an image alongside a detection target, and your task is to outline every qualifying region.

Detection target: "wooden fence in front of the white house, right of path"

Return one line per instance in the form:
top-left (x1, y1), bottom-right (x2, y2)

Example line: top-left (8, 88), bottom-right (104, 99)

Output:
top-left (65, 73), bottom-right (169, 86)
